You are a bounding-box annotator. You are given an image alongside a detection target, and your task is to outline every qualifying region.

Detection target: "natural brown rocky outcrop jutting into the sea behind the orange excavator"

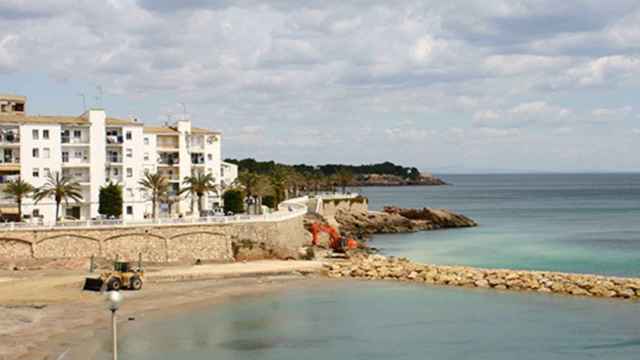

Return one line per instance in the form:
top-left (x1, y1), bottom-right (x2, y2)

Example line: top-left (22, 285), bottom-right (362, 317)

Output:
top-left (335, 206), bottom-right (478, 238)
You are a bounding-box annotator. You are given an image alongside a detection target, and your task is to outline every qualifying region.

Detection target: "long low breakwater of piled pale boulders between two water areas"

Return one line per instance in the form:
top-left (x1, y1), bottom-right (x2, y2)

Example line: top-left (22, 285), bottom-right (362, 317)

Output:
top-left (326, 255), bottom-right (640, 300)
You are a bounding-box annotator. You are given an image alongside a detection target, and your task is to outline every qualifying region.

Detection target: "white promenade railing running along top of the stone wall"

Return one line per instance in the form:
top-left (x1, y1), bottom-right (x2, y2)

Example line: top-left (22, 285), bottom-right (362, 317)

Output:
top-left (0, 197), bottom-right (308, 231)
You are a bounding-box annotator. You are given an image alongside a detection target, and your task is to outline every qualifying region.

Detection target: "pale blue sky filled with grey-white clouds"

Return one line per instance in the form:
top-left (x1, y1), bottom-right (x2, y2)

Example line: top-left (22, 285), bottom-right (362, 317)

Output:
top-left (0, 0), bottom-right (640, 173)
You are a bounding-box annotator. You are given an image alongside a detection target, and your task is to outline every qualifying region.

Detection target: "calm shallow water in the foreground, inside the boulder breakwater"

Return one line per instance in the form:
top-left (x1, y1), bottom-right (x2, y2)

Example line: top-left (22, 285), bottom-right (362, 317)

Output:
top-left (99, 282), bottom-right (640, 360)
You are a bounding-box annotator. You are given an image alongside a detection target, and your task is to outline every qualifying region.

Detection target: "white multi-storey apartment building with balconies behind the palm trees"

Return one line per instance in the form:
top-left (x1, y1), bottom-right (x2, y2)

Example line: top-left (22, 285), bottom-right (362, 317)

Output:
top-left (0, 95), bottom-right (237, 222)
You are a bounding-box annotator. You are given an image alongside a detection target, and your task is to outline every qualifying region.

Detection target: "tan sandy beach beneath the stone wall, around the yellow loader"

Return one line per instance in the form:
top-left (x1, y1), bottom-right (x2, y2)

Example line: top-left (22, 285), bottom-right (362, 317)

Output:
top-left (0, 261), bottom-right (327, 360)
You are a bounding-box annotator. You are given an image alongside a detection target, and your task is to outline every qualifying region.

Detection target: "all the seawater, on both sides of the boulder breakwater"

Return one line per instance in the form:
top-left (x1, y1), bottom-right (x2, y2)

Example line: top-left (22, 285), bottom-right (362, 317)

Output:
top-left (89, 174), bottom-right (640, 360)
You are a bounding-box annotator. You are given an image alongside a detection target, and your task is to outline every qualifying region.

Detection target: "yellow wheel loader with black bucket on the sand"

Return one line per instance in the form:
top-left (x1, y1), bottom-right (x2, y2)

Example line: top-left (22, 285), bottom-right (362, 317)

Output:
top-left (83, 261), bottom-right (144, 292)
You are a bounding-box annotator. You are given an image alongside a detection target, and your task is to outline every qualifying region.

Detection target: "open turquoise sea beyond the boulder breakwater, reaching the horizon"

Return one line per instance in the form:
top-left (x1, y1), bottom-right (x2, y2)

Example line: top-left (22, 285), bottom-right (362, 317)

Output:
top-left (361, 174), bottom-right (640, 276)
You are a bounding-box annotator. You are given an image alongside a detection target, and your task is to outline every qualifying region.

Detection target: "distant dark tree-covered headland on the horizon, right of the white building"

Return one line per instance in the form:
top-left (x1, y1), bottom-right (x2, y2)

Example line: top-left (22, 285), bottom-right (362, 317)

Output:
top-left (225, 158), bottom-right (447, 187)
